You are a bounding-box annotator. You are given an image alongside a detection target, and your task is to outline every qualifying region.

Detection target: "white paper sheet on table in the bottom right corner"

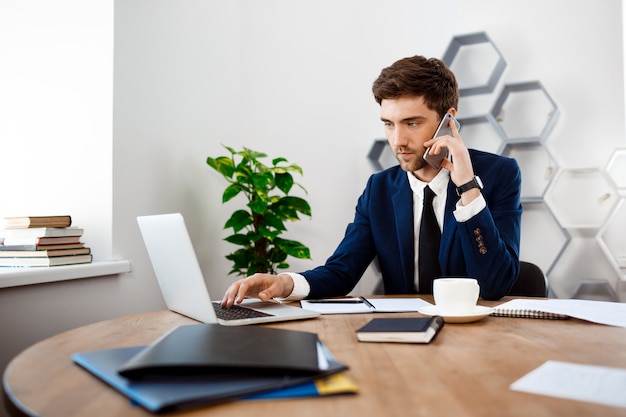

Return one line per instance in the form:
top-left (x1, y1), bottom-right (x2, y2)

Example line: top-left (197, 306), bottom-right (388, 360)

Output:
top-left (511, 361), bottom-right (626, 407)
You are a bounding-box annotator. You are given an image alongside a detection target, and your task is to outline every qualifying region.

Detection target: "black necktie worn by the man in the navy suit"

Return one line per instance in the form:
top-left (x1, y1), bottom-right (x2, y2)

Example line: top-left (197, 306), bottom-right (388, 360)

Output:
top-left (418, 186), bottom-right (441, 294)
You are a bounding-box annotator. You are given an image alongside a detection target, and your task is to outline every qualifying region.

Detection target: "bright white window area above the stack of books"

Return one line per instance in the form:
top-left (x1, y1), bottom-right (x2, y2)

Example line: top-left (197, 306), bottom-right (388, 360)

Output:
top-left (0, 0), bottom-right (113, 260)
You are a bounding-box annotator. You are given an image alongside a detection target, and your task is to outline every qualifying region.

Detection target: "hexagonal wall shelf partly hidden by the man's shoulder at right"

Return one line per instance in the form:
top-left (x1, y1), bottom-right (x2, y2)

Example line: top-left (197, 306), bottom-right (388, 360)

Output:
top-left (502, 143), bottom-right (559, 201)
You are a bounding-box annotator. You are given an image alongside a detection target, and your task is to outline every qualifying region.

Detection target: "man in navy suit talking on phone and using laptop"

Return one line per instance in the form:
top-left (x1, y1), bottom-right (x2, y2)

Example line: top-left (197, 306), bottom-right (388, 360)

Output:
top-left (222, 56), bottom-right (522, 306)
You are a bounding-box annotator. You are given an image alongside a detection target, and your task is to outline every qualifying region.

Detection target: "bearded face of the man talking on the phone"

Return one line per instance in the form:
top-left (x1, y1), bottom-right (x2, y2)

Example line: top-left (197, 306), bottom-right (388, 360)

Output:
top-left (380, 96), bottom-right (439, 172)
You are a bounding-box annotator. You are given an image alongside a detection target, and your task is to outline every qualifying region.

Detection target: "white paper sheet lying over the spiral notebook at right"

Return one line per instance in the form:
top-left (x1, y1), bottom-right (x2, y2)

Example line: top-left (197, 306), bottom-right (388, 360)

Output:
top-left (496, 299), bottom-right (626, 327)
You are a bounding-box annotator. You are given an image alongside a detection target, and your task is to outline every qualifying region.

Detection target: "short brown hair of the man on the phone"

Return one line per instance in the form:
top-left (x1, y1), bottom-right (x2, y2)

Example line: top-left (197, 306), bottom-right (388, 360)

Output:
top-left (372, 55), bottom-right (459, 117)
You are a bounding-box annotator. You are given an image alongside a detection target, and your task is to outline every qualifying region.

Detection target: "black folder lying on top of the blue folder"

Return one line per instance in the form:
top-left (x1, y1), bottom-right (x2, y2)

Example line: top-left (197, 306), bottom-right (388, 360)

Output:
top-left (118, 324), bottom-right (325, 379)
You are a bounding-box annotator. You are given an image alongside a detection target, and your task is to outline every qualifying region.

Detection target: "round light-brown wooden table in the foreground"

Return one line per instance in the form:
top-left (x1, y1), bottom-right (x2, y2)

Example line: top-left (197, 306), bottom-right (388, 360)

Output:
top-left (3, 302), bottom-right (626, 417)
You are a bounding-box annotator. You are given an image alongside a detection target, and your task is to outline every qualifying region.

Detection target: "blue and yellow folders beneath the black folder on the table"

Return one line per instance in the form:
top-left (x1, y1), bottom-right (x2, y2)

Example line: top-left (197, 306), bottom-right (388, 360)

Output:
top-left (72, 342), bottom-right (357, 413)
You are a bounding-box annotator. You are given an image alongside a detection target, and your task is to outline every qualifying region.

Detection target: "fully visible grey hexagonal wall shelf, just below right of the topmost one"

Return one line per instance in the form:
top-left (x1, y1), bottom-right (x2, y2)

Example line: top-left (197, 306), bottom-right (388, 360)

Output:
top-left (491, 81), bottom-right (559, 143)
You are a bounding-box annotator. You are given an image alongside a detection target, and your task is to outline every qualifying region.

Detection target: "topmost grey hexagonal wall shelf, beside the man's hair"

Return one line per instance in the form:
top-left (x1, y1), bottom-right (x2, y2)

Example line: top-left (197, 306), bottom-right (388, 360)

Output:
top-left (442, 32), bottom-right (506, 96)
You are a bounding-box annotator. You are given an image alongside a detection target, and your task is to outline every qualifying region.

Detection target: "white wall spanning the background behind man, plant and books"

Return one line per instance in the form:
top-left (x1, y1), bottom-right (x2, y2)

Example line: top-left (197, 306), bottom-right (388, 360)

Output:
top-left (0, 0), bottom-right (626, 410)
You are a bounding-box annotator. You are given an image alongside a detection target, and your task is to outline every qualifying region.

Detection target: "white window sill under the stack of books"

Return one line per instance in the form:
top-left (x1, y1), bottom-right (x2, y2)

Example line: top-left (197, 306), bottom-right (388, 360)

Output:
top-left (0, 260), bottom-right (130, 288)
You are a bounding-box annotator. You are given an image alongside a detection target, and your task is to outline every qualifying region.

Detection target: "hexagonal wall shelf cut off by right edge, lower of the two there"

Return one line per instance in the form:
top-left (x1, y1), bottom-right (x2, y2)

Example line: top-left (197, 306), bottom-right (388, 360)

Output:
top-left (598, 199), bottom-right (626, 280)
